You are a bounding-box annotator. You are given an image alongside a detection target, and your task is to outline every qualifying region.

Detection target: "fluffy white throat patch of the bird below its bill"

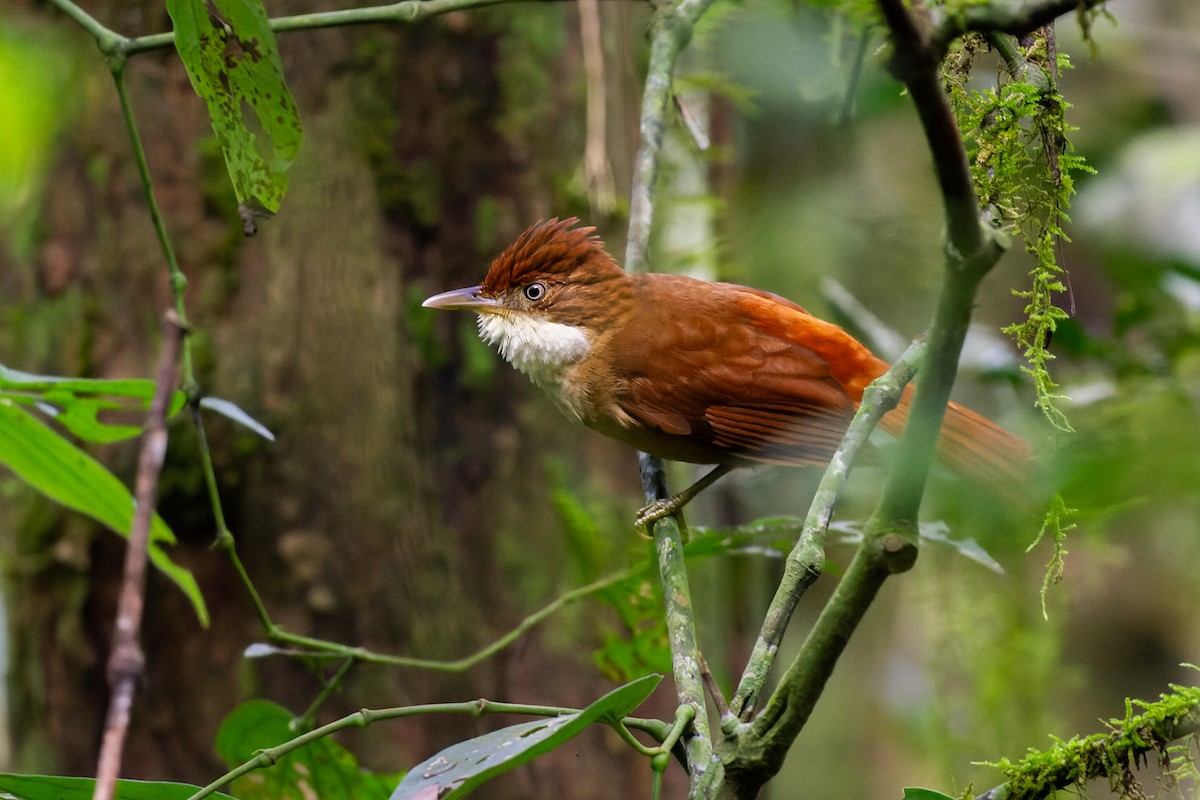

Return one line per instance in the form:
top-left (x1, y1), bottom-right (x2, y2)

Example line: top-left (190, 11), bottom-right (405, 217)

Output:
top-left (479, 313), bottom-right (592, 390)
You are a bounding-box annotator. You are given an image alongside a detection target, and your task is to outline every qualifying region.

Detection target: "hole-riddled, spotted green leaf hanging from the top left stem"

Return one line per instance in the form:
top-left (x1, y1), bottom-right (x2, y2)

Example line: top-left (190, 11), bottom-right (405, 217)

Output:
top-left (167, 0), bottom-right (304, 221)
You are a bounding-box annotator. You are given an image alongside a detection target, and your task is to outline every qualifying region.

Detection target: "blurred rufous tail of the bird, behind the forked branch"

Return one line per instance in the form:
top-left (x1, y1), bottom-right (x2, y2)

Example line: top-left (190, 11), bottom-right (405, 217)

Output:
top-left (880, 386), bottom-right (1033, 501)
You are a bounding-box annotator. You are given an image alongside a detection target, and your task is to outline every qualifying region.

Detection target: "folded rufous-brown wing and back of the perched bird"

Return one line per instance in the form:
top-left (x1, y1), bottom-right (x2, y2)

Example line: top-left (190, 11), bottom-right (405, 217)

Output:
top-left (604, 276), bottom-right (857, 464)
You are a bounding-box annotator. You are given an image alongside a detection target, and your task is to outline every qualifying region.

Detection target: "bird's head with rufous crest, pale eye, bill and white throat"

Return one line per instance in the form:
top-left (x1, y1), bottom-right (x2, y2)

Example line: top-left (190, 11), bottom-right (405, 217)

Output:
top-left (421, 217), bottom-right (631, 387)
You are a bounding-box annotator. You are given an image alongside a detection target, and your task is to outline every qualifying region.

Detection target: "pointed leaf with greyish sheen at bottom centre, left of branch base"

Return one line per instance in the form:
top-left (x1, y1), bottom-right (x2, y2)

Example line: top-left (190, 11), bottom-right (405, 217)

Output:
top-left (391, 675), bottom-right (662, 800)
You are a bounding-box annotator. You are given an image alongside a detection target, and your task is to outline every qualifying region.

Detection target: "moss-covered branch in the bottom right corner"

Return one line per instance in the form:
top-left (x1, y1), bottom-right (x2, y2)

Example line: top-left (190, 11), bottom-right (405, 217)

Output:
top-left (989, 684), bottom-right (1200, 800)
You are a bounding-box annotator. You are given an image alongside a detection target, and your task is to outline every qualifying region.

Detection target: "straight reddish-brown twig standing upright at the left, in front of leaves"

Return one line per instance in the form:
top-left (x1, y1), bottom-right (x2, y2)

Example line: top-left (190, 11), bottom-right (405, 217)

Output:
top-left (92, 311), bottom-right (184, 800)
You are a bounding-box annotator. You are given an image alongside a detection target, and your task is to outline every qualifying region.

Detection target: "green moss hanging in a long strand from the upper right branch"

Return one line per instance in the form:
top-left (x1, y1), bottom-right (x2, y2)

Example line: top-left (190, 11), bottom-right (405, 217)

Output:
top-left (943, 31), bottom-right (1093, 431)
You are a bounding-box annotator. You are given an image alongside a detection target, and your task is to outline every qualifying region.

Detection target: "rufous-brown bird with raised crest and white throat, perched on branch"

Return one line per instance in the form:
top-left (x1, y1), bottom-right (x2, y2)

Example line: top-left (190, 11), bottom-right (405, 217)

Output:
top-left (422, 217), bottom-right (1032, 527)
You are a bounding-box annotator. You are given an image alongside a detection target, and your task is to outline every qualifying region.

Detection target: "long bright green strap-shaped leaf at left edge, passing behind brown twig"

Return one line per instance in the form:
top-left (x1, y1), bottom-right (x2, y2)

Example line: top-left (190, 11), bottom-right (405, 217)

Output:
top-left (0, 397), bottom-right (209, 626)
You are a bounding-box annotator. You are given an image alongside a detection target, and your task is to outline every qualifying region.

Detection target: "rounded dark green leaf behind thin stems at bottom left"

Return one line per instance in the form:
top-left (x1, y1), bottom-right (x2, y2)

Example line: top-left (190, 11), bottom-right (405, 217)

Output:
top-left (216, 700), bottom-right (401, 800)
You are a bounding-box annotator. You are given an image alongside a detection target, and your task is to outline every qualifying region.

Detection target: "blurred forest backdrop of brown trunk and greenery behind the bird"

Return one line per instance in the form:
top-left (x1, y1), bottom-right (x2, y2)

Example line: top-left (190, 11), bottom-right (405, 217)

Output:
top-left (0, 0), bottom-right (1200, 800)
